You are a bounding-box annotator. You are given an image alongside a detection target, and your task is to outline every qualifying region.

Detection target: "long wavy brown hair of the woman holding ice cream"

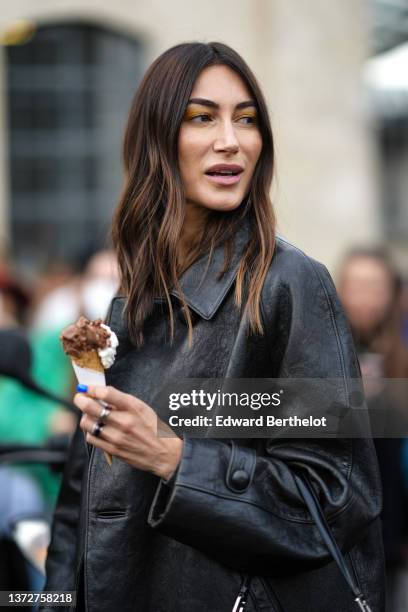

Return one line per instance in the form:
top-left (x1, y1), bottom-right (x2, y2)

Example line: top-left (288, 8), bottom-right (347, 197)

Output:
top-left (112, 42), bottom-right (276, 346)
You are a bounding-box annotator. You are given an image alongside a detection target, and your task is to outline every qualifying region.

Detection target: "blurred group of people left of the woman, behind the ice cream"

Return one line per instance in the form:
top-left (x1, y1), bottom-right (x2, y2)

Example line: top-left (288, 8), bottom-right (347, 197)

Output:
top-left (0, 249), bottom-right (119, 510)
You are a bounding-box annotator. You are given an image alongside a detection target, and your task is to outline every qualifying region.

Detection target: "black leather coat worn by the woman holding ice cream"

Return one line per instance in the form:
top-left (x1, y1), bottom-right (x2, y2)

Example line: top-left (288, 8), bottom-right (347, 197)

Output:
top-left (39, 226), bottom-right (384, 612)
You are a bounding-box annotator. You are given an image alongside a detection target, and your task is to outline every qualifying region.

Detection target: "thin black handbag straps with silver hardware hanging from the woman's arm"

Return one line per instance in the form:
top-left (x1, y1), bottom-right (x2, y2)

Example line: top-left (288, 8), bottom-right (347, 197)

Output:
top-left (232, 472), bottom-right (371, 612)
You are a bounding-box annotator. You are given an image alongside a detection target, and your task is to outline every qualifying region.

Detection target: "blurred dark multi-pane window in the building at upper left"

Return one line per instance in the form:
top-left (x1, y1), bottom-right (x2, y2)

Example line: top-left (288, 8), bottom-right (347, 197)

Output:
top-left (7, 23), bottom-right (144, 273)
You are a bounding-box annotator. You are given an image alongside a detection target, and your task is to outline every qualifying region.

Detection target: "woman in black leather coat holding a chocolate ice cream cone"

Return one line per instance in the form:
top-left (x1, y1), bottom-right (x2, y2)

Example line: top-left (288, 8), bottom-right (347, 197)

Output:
top-left (41, 43), bottom-right (383, 612)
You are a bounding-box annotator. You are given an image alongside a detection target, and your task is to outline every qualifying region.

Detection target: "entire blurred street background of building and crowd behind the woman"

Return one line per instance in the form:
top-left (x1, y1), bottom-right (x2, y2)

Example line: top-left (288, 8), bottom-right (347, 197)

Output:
top-left (0, 0), bottom-right (408, 612)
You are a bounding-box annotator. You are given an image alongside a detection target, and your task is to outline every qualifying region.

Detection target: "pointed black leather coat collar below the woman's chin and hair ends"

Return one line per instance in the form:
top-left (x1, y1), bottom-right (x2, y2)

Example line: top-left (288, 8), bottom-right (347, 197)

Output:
top-left (170, 219), bottom-right (250, 320)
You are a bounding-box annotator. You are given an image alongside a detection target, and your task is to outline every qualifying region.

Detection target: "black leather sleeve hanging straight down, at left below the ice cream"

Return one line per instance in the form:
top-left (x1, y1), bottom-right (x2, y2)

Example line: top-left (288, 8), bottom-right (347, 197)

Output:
top-left (39, 414), bottom-right (88, 612)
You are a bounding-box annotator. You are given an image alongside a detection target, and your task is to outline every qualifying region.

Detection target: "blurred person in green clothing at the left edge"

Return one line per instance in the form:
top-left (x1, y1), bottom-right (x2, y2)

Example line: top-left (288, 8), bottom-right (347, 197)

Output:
top-left (0, 267), bottom-right (75, 510)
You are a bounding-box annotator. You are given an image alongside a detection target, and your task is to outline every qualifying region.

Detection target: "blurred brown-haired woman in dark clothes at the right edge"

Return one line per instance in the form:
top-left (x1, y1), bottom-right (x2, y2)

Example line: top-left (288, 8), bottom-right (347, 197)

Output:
top-left (339, 247), bottom-right (408, 612)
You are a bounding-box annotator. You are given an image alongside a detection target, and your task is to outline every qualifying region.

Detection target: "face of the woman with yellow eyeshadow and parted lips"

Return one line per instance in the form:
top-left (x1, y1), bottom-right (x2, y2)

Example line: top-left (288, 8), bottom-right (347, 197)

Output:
top-left (178, 65), bottom-right (262, 211)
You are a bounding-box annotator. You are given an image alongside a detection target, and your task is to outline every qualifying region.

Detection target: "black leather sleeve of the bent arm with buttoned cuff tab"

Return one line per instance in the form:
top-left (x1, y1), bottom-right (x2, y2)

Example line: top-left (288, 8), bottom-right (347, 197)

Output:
top-left (148, 247), bottom-right (381, 574)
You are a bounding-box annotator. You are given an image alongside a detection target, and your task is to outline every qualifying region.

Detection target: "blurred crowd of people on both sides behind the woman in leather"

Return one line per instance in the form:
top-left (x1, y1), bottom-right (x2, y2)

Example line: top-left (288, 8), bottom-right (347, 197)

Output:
top-left (0, 240), bottom-right (408, 612)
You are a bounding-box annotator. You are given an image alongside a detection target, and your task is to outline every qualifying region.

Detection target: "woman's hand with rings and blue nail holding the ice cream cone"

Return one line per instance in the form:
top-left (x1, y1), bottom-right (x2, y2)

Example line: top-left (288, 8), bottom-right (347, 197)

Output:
top-left (74, 385), bottom-right (183, 479)
